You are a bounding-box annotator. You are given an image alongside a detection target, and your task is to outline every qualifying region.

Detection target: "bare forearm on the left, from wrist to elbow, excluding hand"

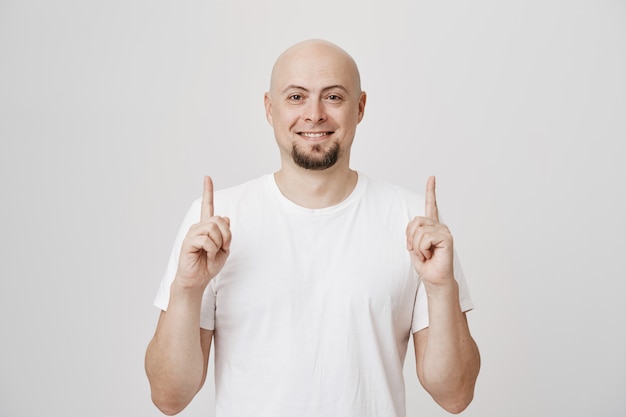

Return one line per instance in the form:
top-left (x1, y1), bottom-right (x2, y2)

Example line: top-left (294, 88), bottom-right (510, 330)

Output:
top-left (146, 280), bottom-right (210, 414)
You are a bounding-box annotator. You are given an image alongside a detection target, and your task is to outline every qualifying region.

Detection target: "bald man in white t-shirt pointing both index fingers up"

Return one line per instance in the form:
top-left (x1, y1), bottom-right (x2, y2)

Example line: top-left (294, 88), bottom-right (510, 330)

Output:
top-left (146, 40), bottom-right (480, 417)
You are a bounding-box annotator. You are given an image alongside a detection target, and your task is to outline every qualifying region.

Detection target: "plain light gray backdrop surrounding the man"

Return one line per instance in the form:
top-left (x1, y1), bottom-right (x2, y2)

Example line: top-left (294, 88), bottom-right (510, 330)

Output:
top-left (0, 0), bottom-right (626, 417)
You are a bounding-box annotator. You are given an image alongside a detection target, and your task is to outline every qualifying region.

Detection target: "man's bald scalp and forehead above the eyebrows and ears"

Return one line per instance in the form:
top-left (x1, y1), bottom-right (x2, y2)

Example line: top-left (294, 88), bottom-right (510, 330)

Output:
top-left (270, 39), bottom-right (361, 95)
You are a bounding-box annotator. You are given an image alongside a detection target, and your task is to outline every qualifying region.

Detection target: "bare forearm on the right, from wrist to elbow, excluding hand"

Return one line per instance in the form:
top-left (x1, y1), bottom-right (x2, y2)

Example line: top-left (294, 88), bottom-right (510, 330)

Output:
top-left (418, 282), bottom-right (480, 412)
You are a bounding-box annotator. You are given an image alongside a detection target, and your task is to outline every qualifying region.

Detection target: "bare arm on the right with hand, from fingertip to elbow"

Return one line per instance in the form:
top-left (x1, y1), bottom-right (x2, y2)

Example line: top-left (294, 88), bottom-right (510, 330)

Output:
top-left (407, 177), bottom-right (480, 414)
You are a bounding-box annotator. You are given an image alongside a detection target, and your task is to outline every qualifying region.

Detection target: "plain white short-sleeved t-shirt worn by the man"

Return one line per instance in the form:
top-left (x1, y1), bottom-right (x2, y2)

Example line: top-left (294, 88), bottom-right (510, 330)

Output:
top-left (155, 173), bottom-right (473, 417)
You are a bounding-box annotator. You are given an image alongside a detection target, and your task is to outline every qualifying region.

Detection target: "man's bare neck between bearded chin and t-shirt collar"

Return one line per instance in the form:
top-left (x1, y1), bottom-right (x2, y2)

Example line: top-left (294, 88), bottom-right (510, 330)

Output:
top-left (274, 166), bottom-right (358, 209)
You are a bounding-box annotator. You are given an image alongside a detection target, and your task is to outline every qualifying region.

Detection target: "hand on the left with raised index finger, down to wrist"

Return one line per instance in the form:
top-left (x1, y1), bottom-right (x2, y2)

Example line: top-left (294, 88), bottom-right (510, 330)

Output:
top-left (176, 177), bottom-right (231, 290)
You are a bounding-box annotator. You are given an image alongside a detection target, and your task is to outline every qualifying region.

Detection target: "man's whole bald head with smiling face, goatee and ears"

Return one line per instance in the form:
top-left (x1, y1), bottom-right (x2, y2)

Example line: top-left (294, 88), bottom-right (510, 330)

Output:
top-left (265, 41), bottom-right (365, 170)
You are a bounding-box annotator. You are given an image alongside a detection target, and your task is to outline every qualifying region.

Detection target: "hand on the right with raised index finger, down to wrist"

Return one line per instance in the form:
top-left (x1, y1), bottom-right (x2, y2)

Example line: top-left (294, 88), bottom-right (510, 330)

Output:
top-left (406, 177), bottom-right (454, 286)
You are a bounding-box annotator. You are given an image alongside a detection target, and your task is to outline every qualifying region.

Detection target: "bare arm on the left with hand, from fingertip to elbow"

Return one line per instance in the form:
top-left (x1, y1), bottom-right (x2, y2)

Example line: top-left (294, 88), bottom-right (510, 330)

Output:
top-left (145, 177), bottom-right (231, 415)
